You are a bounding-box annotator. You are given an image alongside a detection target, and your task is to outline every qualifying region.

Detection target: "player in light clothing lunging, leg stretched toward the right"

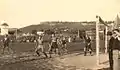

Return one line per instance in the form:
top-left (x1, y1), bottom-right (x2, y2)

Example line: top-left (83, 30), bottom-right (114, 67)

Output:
top-left (35, 36), bottom-right (48, 58)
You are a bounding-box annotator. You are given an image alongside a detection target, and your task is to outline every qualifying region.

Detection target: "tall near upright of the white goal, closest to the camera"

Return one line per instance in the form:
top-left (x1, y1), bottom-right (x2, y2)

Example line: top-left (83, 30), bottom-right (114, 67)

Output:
top-left (96, 16), bottom-right (99, 65)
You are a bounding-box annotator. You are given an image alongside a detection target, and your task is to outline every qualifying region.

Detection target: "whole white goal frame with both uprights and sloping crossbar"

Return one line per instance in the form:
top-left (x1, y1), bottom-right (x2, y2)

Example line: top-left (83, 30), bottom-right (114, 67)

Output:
top-left (96, 16), bottom-right (109, 65)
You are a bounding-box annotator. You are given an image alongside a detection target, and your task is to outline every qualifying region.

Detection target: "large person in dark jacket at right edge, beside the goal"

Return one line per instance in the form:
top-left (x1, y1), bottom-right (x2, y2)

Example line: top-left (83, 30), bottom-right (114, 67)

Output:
top-left (108, 29), bottom-right (120, 70)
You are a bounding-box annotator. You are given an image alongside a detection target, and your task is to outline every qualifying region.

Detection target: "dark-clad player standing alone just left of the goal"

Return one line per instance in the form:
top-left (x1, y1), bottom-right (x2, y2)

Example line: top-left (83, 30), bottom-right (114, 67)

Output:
top-left (84, 35), bottom-right (92, 56)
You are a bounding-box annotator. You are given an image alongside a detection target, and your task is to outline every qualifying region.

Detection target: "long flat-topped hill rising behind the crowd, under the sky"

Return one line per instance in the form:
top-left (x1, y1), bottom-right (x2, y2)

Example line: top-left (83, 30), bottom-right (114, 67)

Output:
top-left (20, 21), bottom-right (113, 33)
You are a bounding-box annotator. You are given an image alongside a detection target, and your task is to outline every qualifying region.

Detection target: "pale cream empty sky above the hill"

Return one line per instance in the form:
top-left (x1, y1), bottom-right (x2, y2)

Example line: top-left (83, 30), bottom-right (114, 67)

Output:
top-left (0, 0), bottom-right (120, 28)
